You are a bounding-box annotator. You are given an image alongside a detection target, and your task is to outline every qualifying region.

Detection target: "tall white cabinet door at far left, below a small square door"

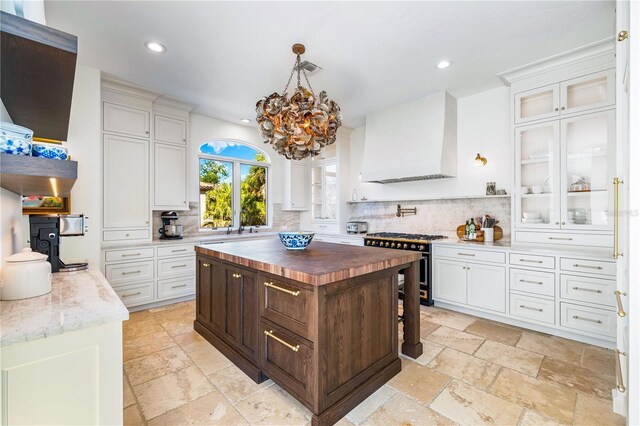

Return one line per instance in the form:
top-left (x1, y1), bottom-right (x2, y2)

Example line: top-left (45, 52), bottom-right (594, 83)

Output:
top-left (102, 133), bottom-right (151, 230)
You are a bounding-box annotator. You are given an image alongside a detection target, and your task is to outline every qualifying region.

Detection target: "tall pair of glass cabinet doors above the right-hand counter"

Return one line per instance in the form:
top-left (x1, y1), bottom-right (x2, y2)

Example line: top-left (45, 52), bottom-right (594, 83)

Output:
top-left (515, 110), bottom-right (615, 231)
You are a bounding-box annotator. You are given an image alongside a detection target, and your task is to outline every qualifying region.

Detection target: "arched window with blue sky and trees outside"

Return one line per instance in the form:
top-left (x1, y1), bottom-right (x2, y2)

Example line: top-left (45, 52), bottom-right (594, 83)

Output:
top-left (199, 140), bottom-right (269, 229)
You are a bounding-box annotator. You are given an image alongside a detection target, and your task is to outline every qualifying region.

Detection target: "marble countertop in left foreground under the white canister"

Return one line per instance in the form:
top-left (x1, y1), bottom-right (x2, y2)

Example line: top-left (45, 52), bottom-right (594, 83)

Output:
top-left (0, 270), bottom-right (129, 347)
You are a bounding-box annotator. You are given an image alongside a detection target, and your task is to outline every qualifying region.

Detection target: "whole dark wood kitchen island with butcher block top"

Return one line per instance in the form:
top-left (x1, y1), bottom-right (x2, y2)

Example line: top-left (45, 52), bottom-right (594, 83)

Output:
top-left (194, 238), bottom-right (422, 425)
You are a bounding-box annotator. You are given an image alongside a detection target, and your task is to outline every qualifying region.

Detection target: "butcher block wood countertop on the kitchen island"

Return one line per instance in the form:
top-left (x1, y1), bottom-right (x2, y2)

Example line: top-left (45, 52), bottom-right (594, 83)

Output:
top-left (196, 238), bottom-right (422, 286)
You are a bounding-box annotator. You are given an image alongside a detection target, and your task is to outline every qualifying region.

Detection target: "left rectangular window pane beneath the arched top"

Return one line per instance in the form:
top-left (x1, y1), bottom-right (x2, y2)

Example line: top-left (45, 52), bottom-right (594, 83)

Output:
top-left (200, 158), bottom-right (233, 228)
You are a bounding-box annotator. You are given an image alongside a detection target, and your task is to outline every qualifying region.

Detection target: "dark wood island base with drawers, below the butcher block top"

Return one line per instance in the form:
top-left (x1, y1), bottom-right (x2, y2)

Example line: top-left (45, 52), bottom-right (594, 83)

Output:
top-left (194, 254), bottom-right (400, 424)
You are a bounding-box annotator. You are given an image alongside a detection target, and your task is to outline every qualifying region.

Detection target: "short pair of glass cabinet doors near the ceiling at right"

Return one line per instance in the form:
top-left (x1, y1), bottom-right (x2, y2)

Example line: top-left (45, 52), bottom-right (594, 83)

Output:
top-left (514, 69), bottom-right (615, 124)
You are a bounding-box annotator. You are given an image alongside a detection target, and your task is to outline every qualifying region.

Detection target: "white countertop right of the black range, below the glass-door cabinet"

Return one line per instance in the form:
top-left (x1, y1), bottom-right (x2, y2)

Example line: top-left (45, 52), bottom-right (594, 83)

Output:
top-left (431, 238), bottom-right (613, 260)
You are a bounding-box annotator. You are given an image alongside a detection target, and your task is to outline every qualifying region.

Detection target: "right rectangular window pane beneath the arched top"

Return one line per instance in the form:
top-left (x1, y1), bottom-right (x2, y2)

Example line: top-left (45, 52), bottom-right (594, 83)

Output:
top-left (240, 164), bottom-right (267, 226)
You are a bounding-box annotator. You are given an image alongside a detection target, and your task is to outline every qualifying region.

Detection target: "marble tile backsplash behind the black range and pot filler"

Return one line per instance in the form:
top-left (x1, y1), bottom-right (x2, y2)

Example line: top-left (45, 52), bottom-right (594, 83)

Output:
top-left (349, 197), bottom-right (511, 239)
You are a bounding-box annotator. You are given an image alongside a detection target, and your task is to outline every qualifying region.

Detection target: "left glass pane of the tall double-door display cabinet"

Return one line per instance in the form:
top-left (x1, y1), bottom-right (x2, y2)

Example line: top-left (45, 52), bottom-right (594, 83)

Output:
top-left (519, 125), bottom-right (557, 226)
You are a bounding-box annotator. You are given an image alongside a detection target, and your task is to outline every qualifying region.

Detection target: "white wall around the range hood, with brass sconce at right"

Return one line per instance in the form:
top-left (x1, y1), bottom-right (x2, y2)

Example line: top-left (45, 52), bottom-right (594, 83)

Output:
top-left (350, 87), bottom-right (513, 200)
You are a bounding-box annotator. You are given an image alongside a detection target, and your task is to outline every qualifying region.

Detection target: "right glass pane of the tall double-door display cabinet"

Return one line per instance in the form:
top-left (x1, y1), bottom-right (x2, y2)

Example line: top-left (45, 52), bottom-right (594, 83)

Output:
top-left (563, 115), bottom-right (612, 227)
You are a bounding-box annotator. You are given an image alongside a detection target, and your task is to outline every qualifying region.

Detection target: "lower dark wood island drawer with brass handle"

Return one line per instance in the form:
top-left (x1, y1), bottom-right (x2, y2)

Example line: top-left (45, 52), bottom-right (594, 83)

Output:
top-left (260, 319), bottom-right (315, 402)
